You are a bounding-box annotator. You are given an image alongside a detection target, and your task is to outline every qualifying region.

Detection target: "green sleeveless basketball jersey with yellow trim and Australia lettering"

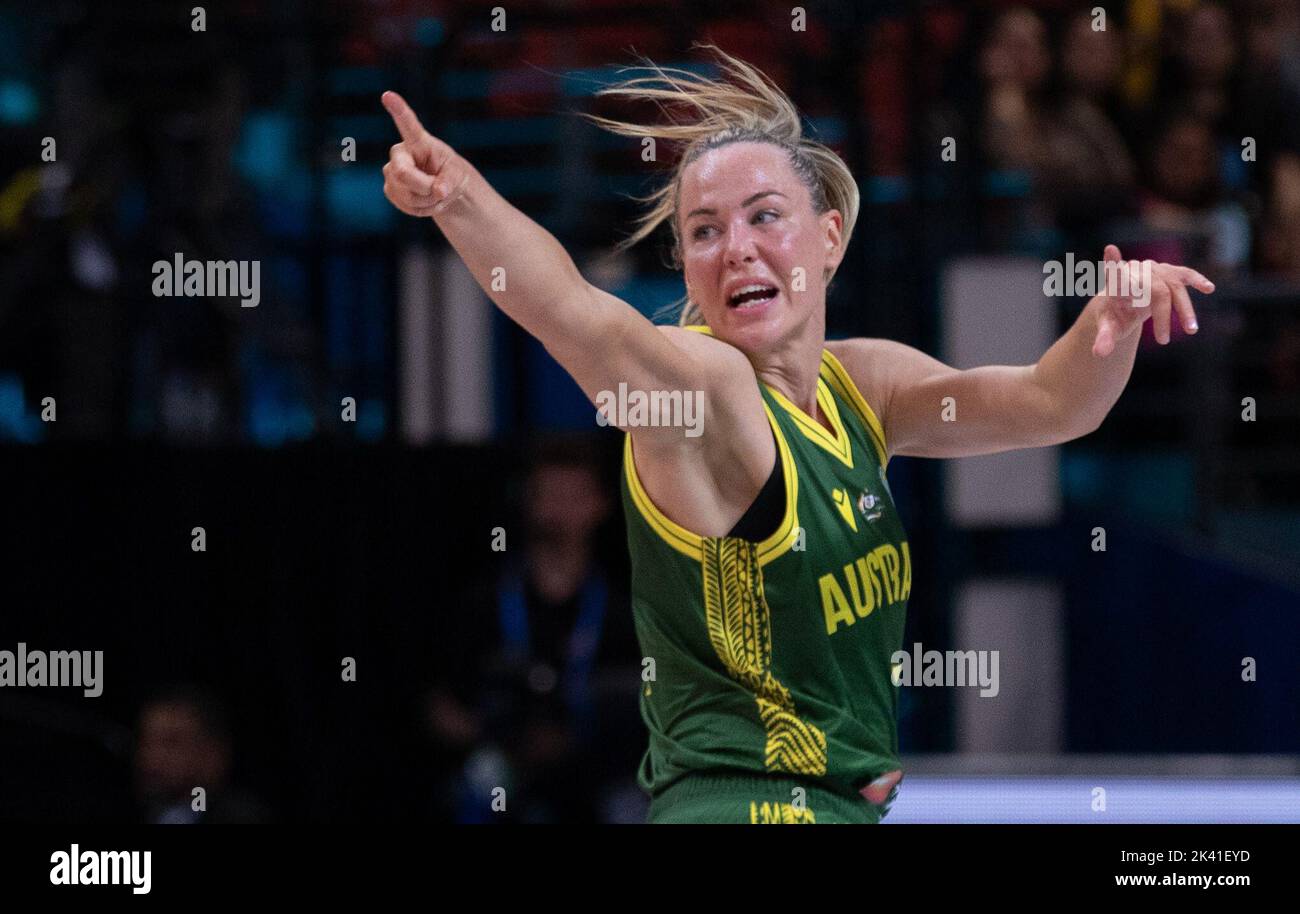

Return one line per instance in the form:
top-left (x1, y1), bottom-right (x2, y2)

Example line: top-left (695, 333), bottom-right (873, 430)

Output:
top-left (623, 340), bottom-right (911, 796)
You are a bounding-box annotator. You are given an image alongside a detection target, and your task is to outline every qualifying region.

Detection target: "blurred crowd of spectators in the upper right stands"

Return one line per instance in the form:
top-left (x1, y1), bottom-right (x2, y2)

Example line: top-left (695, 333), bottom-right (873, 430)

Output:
top-left (936, 0), bottom-right (1300, 273)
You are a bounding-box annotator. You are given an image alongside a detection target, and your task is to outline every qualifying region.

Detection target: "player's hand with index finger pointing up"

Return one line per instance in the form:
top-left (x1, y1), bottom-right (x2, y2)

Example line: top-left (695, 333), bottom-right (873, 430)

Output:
top-left (381, 91), bottom-right (472, 217)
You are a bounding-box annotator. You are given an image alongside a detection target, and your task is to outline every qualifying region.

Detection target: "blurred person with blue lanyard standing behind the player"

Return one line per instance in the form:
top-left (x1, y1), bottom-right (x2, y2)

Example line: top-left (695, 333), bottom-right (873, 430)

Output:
top-left (428, 438), bottom-right (645, 822)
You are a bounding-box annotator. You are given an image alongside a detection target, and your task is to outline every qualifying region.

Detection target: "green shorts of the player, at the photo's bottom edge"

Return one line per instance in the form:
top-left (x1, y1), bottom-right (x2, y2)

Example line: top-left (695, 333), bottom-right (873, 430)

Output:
top-left (647, 774), bottom-right (893, 826)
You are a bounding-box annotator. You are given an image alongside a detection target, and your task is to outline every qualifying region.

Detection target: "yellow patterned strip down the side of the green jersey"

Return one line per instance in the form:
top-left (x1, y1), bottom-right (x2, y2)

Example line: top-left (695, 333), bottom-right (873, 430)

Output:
top-left (703, 537), bottom-right (826, 775)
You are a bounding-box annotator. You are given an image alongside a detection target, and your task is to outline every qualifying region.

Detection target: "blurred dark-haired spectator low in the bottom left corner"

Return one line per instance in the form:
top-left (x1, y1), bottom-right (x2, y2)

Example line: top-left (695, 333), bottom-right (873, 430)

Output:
top-left (134, 686), bottom-right (270, 824)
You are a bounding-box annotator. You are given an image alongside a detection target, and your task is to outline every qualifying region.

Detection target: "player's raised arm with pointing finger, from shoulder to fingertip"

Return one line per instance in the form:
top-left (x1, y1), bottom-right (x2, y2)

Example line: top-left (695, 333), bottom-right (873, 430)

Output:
top-left (384, 92), bottom-right (775, 533)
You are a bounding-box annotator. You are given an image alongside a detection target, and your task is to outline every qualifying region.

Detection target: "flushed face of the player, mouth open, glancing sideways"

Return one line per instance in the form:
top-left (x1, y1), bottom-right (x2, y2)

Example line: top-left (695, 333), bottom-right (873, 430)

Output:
top-left (677, 142), bottom-right (842, 352)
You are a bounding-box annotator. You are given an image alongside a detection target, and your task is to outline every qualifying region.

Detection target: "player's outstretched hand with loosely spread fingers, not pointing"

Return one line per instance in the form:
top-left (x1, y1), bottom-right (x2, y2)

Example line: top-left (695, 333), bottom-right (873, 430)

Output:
top-left (1092, 244), bottom-right (1214, 358)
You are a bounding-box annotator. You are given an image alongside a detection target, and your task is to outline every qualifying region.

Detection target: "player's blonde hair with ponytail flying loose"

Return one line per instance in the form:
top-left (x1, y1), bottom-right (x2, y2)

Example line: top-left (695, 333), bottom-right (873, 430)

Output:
top-left (582, 44), bottom-right (859, 326)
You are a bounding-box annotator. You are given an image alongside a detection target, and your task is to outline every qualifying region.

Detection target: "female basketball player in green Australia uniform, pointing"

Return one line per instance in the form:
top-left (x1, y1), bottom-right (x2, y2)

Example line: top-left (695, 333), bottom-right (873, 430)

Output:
top-left (384, 48), bottom-right (1213, 823)
